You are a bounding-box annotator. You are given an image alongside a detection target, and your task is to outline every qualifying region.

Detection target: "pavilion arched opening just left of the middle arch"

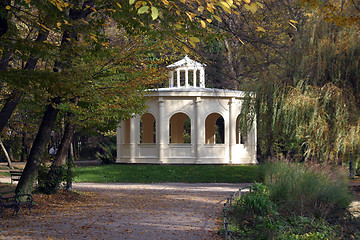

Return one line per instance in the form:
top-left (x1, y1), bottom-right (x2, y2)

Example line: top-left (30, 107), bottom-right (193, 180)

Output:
top-left (140, 113), bottom-right (156, 143)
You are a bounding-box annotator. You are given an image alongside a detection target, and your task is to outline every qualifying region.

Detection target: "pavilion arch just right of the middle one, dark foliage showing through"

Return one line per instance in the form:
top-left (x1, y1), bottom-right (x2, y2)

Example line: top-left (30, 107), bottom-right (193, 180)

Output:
top-left (205, 113), bottom-right (225, 144)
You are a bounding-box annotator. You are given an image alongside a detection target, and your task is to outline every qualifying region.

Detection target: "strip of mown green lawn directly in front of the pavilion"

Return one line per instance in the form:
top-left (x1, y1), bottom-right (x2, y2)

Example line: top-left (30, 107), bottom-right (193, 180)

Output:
top-left (74, 164), bottom-right (261, 183)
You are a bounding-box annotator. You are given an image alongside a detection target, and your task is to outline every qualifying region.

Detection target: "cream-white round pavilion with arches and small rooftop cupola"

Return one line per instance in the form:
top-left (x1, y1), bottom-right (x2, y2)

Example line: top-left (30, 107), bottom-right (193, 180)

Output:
top-left (116, 56), bottom-right (257, 164)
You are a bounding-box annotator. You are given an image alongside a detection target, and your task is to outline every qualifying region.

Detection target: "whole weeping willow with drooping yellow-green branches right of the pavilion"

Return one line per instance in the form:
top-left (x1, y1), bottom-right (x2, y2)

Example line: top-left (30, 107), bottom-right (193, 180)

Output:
top-left (236, 0), bottom-right (360, 163)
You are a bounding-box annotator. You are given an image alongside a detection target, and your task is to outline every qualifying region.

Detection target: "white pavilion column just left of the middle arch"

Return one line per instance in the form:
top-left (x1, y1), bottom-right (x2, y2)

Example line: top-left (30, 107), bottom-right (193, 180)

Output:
top-left (156, 97), bottom-right (168, 163)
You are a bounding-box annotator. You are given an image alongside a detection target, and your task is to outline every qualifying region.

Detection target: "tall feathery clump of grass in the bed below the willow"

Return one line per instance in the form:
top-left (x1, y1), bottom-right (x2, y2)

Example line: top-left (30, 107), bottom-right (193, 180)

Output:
top-left (265, 162), bottom-right (352, 220)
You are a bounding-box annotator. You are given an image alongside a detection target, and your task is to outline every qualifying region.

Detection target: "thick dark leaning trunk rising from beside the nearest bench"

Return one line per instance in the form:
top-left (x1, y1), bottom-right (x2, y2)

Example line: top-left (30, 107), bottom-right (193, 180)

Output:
top-left (15, 101), bottom-right (59, 193)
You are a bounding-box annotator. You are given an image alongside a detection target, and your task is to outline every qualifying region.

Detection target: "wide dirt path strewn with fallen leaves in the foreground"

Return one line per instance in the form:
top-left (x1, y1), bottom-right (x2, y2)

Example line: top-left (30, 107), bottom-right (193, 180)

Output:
top-left (0, 183), bottom-right (245, 240)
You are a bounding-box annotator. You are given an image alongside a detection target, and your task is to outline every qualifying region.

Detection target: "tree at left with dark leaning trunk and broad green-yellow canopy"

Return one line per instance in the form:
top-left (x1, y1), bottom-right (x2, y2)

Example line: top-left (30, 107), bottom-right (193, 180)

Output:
top-left (1, 0), bottom-right (230, 192)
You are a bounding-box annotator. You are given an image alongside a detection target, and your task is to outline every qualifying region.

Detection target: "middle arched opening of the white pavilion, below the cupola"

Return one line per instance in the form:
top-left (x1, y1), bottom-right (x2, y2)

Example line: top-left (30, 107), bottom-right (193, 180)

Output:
top-left (169, 113), bottom-right (191, 143)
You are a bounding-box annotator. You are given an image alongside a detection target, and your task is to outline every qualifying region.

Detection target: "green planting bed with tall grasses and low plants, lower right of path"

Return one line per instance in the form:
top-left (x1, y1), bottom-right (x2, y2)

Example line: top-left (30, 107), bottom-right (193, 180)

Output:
top-left (228, 162), bottom-right (360, 239)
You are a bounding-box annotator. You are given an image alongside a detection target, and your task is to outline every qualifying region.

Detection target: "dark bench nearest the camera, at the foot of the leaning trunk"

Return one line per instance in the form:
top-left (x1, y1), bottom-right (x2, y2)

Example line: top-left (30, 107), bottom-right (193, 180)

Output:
top-left (0, 194), bottom-right (34, 216)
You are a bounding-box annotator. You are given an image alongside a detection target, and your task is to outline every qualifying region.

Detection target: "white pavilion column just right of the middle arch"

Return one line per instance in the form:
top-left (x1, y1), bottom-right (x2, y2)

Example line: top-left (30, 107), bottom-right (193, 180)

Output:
top-left (195, 97), bottom-right (201, 163)
